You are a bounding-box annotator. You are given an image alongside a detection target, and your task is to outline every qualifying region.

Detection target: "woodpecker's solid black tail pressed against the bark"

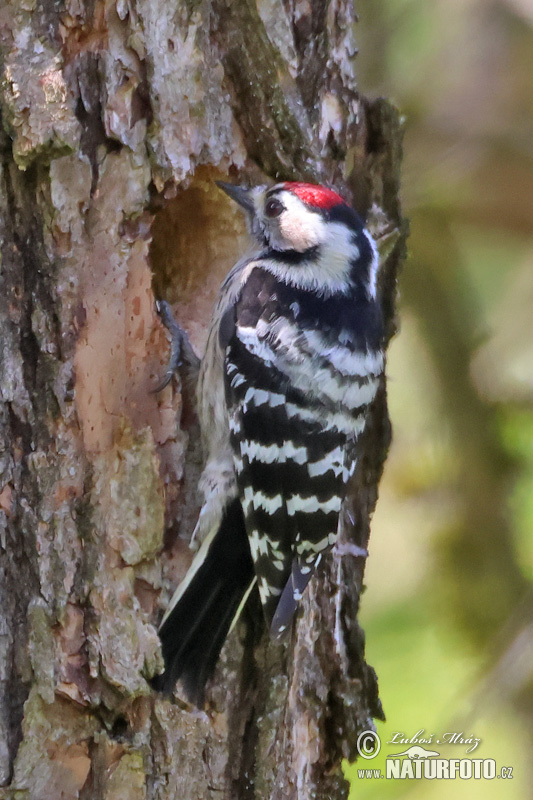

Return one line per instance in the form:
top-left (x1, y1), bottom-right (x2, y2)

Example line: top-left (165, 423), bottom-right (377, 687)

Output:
top-left (152, 499), bottom-right (254, 707)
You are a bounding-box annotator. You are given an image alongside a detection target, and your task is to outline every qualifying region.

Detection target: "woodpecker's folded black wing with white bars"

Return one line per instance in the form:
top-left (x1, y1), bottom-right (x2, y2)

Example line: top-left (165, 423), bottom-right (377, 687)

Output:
top-left (222, 268), bottom-right (380, 636)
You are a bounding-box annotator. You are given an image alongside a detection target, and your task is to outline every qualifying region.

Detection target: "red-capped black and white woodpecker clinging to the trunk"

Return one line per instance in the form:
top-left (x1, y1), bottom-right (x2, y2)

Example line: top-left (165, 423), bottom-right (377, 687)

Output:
top-left (154, 182), bottom-right (384, 706)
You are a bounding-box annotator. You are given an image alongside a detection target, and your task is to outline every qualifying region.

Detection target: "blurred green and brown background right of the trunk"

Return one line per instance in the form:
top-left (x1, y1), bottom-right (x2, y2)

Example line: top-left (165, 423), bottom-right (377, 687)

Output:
top-left (348, 0), bottom-right (533, 800)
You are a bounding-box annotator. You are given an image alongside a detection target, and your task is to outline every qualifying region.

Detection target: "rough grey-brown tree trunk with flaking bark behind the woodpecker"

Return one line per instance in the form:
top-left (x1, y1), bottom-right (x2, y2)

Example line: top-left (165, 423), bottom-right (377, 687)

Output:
top-left (0, 0), bottom-right (404, 800)
